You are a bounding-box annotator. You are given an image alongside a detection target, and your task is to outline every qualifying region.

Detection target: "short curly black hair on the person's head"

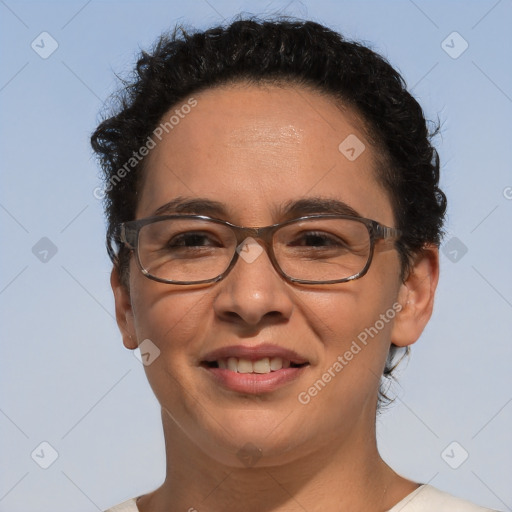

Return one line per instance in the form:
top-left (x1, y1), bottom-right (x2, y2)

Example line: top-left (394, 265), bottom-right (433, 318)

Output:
top-left (91, 18), bottom-right (446, 406)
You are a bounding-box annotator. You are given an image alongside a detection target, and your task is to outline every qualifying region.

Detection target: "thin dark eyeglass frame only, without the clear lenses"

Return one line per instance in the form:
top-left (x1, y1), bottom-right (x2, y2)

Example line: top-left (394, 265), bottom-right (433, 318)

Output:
top-left (117, 214), bottom-right (402, 285)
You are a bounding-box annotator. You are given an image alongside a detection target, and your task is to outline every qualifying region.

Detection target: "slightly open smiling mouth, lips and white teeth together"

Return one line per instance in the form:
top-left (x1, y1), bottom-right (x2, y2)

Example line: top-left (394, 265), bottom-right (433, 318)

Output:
top-left (200, 345), bottom-right (310, 395)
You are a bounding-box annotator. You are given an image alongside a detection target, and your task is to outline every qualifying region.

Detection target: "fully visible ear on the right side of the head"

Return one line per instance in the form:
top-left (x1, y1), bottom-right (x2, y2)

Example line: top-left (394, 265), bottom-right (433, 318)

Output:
top-left (391, 245), bottom-right (439, 347)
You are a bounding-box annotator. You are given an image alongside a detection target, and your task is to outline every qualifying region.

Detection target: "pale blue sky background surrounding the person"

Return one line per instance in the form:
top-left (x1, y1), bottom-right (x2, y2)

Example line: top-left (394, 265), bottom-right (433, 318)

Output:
top-left (0, 0), bottom-right (512, 512)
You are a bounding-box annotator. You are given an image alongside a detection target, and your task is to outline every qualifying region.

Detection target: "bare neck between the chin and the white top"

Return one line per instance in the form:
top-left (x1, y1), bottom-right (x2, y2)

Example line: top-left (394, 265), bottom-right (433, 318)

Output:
top-left (137, 408), bottom-right (418, 512)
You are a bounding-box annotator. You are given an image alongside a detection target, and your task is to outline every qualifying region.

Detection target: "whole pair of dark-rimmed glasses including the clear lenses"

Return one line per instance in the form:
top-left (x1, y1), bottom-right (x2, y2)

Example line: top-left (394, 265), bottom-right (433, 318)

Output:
top-left (119, 214), bottom-right (400, 285)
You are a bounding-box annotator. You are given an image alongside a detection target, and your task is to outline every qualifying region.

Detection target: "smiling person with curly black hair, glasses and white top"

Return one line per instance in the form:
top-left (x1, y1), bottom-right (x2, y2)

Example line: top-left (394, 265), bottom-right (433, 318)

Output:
top-left (92, 20), bottom-right (496, 512)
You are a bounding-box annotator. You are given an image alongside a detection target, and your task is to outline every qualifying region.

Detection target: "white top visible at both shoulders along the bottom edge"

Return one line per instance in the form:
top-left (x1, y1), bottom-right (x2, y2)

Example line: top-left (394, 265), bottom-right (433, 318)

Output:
top-left (105, 484), bottom-right (496, 512)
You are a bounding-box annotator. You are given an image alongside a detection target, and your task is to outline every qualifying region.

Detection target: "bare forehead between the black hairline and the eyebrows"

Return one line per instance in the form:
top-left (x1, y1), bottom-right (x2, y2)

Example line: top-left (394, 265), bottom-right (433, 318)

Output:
top-left (137, 84), bottom-right (392, 223)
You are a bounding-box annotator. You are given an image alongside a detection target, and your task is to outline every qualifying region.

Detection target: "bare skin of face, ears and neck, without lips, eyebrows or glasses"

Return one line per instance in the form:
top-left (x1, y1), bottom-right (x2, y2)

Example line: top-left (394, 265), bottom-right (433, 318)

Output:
top-left (112, 84), bottom-right (438, 512)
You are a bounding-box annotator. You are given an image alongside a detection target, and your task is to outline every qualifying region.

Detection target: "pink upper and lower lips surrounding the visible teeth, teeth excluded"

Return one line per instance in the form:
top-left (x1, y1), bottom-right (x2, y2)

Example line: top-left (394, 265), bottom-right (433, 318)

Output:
top-left (200, 344), bottom-right (309, 395)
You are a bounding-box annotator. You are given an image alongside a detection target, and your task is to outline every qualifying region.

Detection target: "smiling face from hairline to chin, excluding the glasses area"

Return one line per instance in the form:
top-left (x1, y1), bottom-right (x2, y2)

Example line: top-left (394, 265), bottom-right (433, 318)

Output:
top-left (113, 85), bottom-right (435, 466)
